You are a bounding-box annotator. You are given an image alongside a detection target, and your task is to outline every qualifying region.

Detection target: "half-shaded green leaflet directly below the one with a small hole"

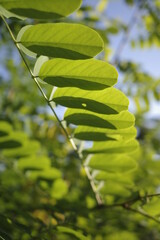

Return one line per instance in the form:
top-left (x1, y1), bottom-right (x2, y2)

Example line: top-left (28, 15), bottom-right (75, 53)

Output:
top-left (64, 109), bottom-right (135, 129)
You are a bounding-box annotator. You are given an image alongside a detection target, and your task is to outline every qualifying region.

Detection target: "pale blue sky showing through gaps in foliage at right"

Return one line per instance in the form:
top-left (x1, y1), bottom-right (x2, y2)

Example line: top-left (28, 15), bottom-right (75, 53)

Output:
top-left (105, 0), bottom-right (160, 118)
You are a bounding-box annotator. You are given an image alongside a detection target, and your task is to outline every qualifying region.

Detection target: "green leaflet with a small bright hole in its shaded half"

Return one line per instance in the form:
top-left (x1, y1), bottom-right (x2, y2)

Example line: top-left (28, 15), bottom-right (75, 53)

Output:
top-left (52, 88), bottom-right (129, 114)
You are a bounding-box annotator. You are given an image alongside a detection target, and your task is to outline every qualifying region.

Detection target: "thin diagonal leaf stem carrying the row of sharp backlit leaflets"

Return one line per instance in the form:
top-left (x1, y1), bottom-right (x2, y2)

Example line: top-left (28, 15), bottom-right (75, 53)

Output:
top-left (1, 16), bottom-right (103, 205)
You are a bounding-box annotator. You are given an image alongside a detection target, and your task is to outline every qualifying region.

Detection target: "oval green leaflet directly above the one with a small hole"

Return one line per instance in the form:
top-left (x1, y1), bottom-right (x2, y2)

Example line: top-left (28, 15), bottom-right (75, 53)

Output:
top-left (38, 59), bottom-right (118, 90)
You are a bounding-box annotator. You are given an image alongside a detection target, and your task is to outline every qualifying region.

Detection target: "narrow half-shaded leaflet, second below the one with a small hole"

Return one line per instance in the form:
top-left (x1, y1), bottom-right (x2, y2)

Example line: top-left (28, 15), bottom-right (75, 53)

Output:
top-left (74, 125), bottom-right (137, 141)
